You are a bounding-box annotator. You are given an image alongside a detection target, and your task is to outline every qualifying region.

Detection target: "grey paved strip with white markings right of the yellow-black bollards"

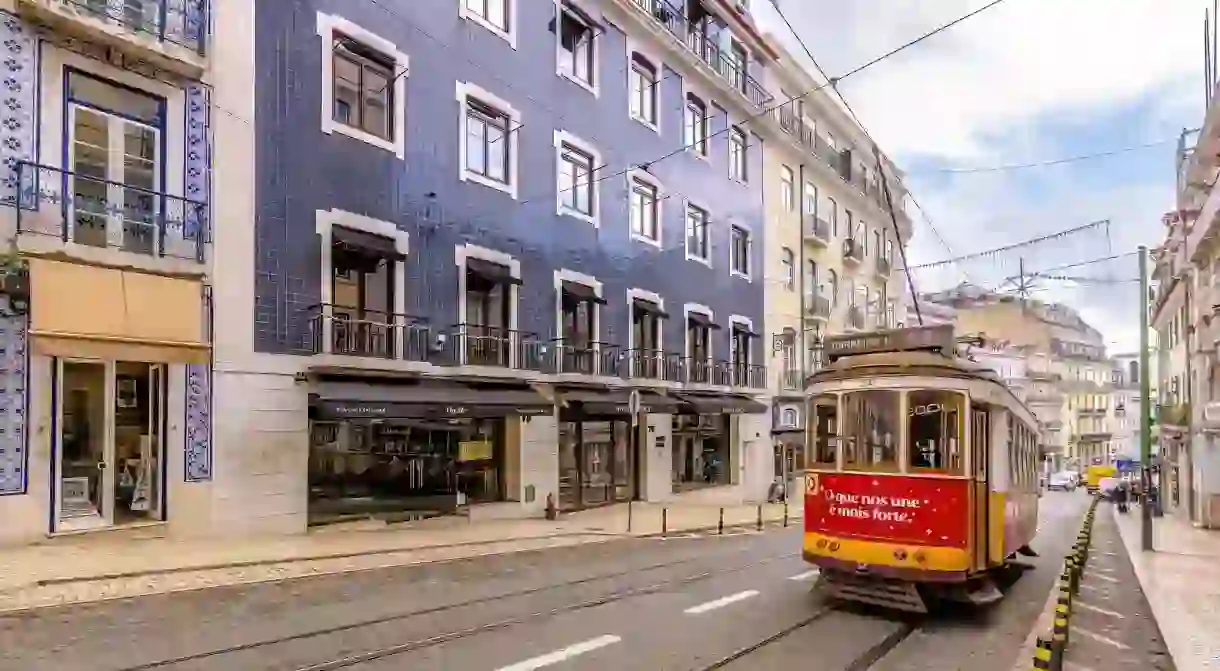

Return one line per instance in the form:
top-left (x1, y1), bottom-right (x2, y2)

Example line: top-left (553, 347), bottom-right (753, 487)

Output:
top-left (1065, 503), bottom-right (1174, 671)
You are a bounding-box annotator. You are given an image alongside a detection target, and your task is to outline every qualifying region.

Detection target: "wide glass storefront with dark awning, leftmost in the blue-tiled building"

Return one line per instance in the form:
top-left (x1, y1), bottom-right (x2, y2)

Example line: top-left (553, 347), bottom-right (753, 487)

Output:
top-left (309, 381), bottom-right (555, 523)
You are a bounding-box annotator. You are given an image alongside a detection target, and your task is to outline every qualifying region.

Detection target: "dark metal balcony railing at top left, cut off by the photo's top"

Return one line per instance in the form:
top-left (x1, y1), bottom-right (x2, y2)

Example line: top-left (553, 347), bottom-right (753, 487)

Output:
top-left (52, 0), bottom-right (209, 55)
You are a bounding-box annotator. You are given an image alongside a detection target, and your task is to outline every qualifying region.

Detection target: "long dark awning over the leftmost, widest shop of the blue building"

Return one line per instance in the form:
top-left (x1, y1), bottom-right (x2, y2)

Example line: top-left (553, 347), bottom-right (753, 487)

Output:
top-left (309, 382), bottom-right (555, 420)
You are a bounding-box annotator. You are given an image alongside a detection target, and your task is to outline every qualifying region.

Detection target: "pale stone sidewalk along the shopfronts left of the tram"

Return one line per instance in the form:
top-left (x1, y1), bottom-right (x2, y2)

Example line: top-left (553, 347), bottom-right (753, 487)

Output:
top-left (0, 503), bottom-right (799, 612)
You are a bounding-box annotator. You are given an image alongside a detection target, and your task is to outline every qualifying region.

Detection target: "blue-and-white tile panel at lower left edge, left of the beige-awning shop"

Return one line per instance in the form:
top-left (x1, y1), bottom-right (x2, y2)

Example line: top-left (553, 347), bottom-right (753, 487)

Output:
top-left (0, 296), bottom-right (29, 495)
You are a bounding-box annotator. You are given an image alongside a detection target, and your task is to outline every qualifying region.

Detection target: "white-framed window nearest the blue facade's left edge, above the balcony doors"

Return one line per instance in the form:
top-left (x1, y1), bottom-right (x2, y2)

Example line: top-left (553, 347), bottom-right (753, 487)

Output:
top-left (332, 34), bottom-right (395, 140)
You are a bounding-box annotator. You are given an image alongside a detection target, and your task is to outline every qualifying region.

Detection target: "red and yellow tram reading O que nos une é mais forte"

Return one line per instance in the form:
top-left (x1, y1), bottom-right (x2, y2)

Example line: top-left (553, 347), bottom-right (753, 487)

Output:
top-left (803, 326), bottom-right (1039, 612)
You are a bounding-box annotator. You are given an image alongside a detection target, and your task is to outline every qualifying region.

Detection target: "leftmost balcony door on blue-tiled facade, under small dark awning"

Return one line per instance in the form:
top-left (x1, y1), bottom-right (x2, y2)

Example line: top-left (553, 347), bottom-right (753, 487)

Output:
top-left (322, 226), bottom-right (401, 357)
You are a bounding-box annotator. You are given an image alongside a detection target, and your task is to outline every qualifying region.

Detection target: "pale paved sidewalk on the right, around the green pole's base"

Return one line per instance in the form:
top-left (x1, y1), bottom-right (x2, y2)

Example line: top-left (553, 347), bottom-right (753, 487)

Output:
top-left (1114, 506), bottom-right (1220, 671)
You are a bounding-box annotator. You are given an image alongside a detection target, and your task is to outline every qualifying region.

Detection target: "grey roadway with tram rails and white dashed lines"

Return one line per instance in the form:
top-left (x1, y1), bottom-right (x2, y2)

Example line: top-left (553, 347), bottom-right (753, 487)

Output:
top-left (0, 494), bottom-right (1085, 671)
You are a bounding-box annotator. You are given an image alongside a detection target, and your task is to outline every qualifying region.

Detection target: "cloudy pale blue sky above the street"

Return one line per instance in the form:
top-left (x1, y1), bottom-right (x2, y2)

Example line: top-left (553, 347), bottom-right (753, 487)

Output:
top-left (752, 0), bottom-right (1210, 353)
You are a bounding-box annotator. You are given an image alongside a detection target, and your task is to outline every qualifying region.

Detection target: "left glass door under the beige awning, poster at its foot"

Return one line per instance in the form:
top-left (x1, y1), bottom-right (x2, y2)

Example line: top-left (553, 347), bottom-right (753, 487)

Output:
top-left (54, 360), bottom-right (115, 531)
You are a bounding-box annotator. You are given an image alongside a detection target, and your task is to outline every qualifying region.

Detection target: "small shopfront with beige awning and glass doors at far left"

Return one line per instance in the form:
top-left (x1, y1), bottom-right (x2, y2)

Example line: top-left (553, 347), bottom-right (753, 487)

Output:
top-left (17, 259), bottom-right (210, 533)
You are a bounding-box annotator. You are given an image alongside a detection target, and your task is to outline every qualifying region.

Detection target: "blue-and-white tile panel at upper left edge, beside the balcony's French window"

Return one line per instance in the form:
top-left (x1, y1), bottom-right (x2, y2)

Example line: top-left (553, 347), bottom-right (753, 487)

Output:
top-left (0, 12), bottom-right (38, 205)
